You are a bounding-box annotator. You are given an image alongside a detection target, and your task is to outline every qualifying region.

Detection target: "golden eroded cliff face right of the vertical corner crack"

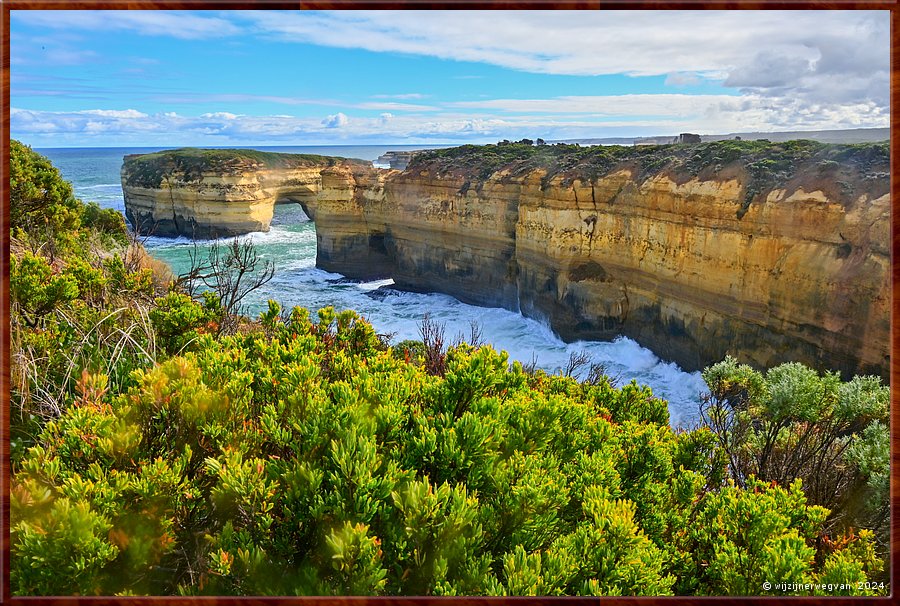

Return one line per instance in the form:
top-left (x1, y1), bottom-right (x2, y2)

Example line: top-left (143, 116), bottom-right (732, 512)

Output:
top-left (516, 174), bottom-right (890, 375)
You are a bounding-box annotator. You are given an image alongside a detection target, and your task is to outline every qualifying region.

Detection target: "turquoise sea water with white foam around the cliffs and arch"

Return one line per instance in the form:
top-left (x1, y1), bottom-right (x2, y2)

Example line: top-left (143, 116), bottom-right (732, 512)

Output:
top-left (37, 146), bottom-right (705, 426)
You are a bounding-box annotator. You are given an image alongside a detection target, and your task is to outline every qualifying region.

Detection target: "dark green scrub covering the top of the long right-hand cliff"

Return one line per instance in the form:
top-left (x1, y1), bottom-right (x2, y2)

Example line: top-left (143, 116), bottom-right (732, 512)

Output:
top-left (407, 140), bottom-right (890, 216)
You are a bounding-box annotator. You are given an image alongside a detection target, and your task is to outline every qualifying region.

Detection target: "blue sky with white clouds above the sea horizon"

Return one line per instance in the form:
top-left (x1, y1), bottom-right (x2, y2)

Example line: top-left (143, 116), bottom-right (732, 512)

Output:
top-left (10, 10), bottom-right (890, 147)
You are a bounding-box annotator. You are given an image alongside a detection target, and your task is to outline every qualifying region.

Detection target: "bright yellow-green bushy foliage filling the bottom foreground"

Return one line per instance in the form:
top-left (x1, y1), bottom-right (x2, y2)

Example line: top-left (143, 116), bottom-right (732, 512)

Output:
top-left (5, 304), bottom-right (877, 595)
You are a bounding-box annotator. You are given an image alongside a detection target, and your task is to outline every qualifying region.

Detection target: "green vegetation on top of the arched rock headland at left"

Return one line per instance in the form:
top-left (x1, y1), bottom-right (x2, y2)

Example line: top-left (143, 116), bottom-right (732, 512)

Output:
top-left (123, 147), bottom-right (370, 187)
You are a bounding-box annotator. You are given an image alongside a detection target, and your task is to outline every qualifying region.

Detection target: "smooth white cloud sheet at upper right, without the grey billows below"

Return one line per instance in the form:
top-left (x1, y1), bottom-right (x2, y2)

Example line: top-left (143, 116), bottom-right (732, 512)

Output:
top-left (241, 11), bottom-right (888, 75)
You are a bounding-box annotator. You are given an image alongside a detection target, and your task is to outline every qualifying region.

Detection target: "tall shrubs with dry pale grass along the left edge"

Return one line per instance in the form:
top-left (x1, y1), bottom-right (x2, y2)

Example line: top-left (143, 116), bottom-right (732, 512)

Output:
top-left (9, 141), bottom-right (165, 464)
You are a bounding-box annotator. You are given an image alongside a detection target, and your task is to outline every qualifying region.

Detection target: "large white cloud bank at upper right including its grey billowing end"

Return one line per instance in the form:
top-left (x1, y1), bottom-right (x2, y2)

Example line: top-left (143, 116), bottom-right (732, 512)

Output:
top-left (241, 11), bottom-right (890, 114)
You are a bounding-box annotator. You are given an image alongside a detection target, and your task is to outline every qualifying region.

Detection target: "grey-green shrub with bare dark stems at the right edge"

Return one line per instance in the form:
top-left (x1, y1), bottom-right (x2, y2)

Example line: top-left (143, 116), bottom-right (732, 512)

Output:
top-left (701, 357), bottom-right (890, 564)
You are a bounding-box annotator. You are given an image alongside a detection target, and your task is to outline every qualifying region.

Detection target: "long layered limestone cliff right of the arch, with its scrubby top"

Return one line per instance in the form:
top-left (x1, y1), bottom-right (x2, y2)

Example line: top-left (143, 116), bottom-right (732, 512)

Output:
top-left (121, 141), bottom-right (891, 377)
